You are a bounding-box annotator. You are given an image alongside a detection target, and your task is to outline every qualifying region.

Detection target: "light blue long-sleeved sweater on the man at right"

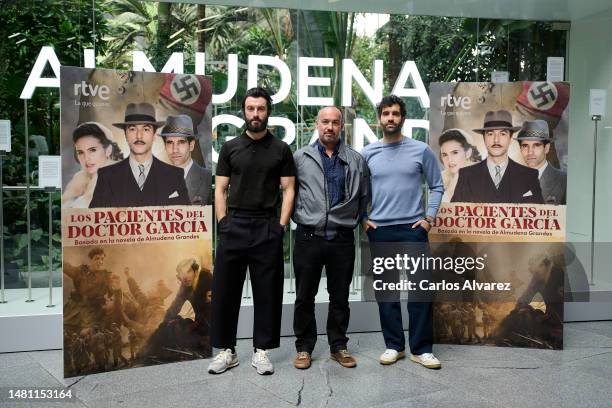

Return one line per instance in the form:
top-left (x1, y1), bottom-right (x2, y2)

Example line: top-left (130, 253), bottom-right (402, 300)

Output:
top-left (361, 137), bottom-right (444, 226)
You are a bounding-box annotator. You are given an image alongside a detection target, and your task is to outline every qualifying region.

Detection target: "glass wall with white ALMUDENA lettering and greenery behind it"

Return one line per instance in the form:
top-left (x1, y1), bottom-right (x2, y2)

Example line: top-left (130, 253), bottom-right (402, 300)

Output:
top-left (0, 0), bottom-right (569, 302)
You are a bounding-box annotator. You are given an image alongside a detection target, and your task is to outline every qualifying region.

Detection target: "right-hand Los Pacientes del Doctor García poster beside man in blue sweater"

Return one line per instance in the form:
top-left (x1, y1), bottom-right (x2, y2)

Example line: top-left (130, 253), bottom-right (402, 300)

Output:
top-left (430, 81), bottom-right (570, 349)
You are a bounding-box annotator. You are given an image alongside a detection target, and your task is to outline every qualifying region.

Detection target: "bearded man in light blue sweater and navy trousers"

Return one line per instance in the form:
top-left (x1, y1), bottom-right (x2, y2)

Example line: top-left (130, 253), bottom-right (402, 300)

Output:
top-left (362, 95), bottom-right (444, 368)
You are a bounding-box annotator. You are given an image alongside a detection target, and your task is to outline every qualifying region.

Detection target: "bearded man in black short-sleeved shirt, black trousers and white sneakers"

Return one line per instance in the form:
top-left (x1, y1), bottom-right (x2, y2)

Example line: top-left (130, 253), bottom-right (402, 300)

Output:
top-left (208, 88), bottom-right (295, 374)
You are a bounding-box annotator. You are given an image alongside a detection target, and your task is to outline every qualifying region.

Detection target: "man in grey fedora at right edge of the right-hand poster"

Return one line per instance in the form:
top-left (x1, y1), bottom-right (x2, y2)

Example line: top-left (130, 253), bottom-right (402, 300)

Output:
top-left (516, 119), bottom-right (567, 205)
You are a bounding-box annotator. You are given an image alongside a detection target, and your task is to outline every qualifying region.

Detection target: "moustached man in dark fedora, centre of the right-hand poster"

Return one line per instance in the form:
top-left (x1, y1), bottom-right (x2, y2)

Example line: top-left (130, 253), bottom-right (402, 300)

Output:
top-left (451, 110), bottom-right (544, 204)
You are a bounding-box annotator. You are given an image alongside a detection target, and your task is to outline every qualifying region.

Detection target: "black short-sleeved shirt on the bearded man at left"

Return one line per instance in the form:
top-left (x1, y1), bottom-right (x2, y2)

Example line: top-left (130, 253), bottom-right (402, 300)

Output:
top-left (216, 132), bottom-right (295, 211)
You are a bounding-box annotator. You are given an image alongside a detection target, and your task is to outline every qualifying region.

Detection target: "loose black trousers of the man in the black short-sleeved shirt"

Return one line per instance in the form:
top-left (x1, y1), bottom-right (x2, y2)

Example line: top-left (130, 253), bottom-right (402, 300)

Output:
top-left (211, 213), bottom-right (284, 349)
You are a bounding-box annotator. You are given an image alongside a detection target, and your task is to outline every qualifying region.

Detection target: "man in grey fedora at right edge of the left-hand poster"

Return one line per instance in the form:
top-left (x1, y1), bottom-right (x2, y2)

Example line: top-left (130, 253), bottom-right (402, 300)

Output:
top-left (159, 115), bottom-right (212, 205)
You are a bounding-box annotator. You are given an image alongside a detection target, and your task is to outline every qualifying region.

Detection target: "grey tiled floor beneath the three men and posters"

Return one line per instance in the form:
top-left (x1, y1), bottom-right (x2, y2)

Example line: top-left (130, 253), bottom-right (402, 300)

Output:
top-left (0, 322), bottom-right (612, 408)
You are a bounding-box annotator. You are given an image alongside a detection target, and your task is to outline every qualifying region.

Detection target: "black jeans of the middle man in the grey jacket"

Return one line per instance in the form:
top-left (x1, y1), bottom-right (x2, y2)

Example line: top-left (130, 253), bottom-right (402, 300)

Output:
top-left (293, 225), bottom-right (355, 353)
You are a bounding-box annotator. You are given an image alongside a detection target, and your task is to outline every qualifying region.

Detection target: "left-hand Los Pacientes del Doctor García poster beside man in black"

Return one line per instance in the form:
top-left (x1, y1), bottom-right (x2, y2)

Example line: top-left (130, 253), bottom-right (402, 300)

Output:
top-left (60, 67), bottom-right (213, 377)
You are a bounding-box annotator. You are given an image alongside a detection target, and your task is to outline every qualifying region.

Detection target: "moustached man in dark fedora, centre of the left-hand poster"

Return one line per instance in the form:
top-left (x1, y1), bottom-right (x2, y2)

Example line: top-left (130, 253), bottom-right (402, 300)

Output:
top-left (89, 103), bottom-right (189, 208)
